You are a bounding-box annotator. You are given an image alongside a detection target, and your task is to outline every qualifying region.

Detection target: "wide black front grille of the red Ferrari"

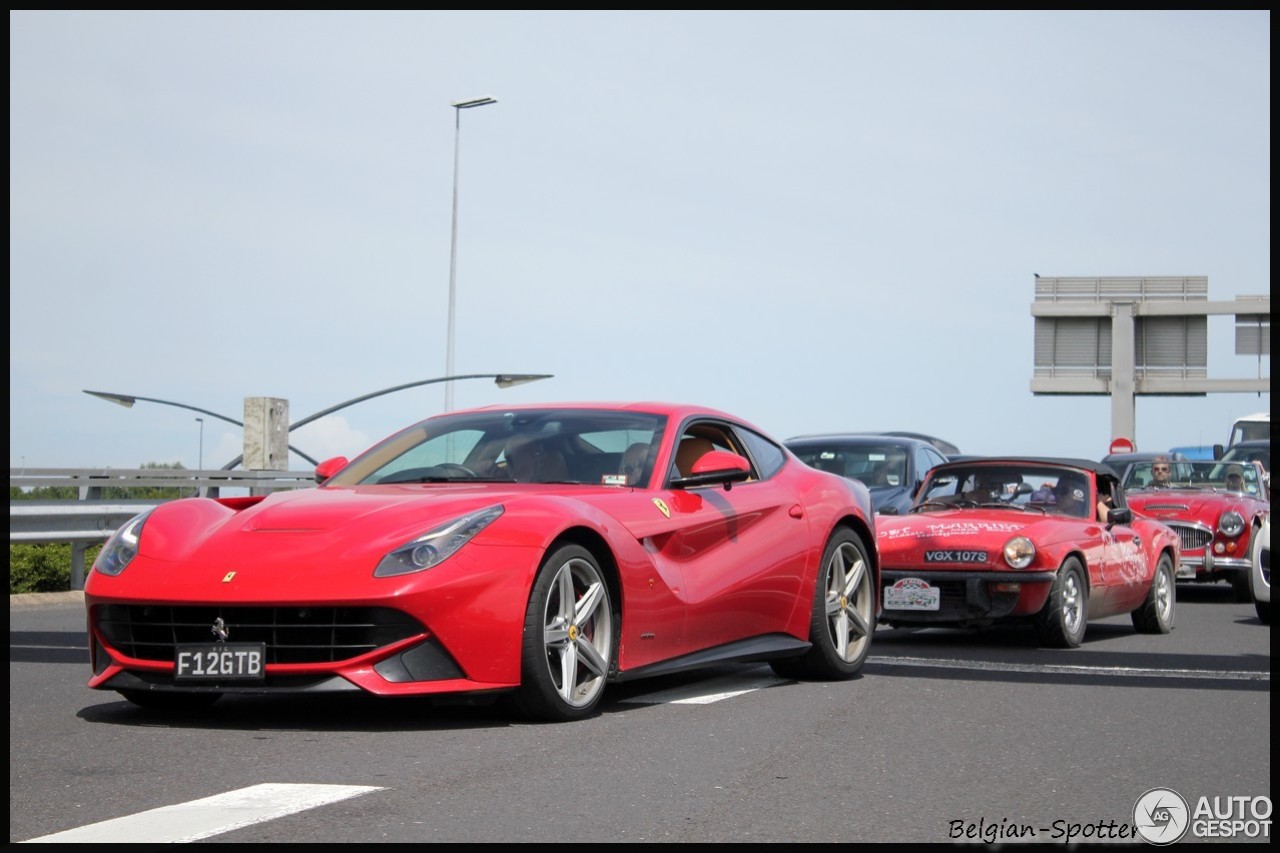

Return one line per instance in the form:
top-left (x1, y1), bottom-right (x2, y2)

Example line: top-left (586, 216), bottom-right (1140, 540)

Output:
top-left (93, 605), bottom-right (424, 663)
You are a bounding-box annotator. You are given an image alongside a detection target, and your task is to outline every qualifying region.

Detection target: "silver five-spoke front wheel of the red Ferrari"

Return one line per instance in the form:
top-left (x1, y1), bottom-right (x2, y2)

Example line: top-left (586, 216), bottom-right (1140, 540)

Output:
top-left (515, 546), bottom-right (617, 722)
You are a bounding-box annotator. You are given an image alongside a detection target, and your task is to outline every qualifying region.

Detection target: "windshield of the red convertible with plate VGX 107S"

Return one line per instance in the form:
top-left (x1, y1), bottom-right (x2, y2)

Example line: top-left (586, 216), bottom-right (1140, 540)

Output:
top-left (913, 461), bottom-right (1094, 517)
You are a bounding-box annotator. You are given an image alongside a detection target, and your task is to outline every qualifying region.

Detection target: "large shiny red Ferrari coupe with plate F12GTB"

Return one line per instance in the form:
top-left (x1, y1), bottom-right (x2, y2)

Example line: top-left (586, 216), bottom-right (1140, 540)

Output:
top-left (84, 403), bottom-right (879, 721)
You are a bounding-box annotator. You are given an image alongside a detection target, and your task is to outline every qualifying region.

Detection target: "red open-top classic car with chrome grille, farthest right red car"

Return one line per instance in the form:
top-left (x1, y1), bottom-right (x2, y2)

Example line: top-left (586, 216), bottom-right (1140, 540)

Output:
top-left (1124, 460), bottom-right (1271, 602)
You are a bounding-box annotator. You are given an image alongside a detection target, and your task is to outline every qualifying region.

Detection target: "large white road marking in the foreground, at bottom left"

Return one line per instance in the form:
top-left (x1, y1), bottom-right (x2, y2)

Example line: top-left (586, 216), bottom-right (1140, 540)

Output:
top-left (27, 783), bottom-right (381, 844)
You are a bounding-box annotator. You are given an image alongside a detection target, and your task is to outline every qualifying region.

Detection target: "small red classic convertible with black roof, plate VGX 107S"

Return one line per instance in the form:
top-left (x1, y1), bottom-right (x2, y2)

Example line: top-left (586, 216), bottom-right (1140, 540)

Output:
top-left (877, 456), bottom-right (1179, 648)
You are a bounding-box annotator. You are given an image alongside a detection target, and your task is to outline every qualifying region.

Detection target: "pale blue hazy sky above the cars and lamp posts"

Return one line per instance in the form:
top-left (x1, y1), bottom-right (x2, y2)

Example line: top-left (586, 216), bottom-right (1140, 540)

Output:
top-left (9, 10), bottom-right (1271, 469)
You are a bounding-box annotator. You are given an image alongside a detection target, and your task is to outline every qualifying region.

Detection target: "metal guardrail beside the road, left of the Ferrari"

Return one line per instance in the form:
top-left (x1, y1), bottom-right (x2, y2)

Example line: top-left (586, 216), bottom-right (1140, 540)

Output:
top-left (9, 467), bottom-right (315, 589)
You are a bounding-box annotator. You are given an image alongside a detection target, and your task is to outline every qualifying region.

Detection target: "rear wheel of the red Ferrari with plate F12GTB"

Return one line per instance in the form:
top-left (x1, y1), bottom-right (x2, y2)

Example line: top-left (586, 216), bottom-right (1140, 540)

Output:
top-left (769, 529), bottom-right (876, 680)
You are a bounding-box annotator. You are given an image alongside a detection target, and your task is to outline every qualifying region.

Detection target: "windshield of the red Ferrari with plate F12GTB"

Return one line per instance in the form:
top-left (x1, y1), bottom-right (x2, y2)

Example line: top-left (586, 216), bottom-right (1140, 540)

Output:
top-left (325, 409), bottom-right (666, 485)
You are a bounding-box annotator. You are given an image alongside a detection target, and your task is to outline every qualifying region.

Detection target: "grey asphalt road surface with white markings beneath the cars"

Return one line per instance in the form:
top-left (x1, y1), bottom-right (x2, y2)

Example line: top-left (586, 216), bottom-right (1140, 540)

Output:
top-left (9, 584), bottom-right (1271, 843)
